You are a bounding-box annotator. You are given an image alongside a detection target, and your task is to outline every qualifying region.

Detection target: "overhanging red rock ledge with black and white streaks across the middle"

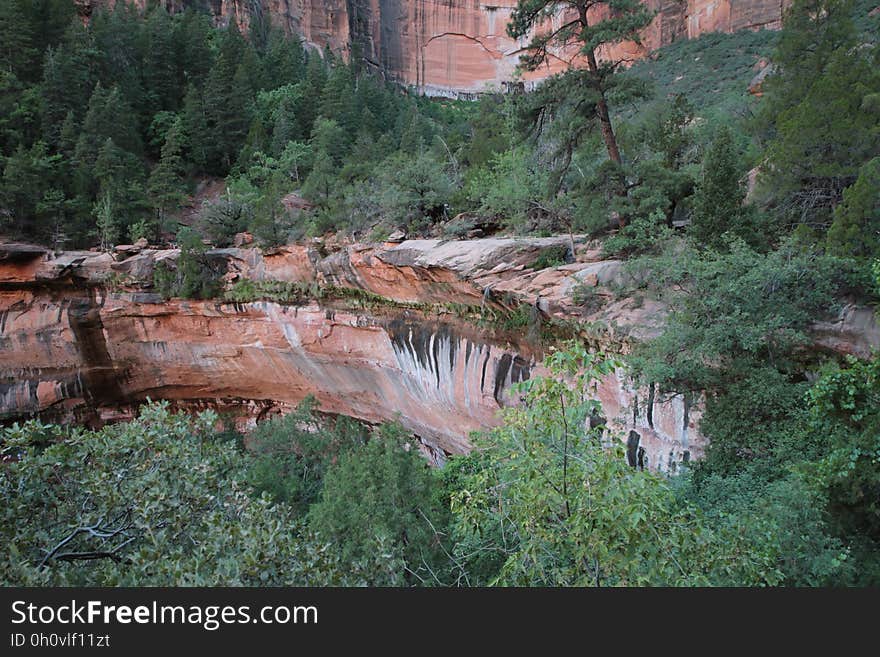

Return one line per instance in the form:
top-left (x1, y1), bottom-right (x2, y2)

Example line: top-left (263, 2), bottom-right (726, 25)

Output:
top-left (0, 237), bottom-right (880, 471)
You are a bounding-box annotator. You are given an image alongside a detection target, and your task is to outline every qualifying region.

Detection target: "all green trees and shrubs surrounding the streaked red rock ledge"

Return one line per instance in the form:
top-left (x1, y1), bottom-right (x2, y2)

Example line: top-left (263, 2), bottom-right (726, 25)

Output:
top-left (0, 0), bottom-right (880, 586)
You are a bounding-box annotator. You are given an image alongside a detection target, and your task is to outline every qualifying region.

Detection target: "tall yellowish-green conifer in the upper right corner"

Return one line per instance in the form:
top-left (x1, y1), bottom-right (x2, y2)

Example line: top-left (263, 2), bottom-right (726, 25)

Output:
top-left (761, 0), bottom-right (880, 231)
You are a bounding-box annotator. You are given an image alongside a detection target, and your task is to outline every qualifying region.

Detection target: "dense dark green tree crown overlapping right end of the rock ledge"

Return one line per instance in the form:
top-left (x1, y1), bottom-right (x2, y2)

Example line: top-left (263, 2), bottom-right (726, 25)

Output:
top-left (632, 239), bottom-right (852, 392)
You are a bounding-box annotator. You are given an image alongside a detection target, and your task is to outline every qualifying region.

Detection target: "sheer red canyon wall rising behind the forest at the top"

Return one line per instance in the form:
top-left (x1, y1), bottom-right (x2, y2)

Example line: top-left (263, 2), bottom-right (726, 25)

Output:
top-left (77, 0), bottom-right (789, 96)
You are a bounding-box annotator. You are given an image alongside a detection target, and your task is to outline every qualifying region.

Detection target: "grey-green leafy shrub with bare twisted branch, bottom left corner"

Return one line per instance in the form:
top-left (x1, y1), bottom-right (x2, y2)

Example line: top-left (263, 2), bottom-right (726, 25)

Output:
top-left (0, 403), bottom-right (382, 586)
